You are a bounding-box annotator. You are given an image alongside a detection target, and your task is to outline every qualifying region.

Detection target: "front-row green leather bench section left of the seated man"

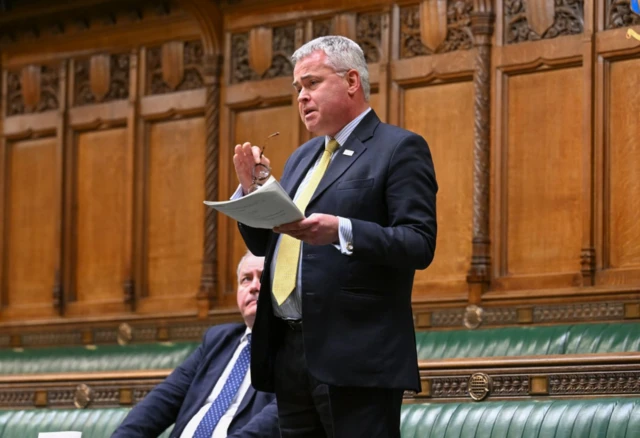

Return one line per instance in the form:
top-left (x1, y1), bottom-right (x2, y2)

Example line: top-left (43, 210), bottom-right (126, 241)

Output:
top-left (0, 408), bottom-right (172, 438)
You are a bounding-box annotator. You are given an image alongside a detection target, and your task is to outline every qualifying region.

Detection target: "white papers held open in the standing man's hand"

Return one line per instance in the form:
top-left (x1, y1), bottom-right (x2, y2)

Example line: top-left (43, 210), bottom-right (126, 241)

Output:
top-left (204, 177), bottom-right (304, 229)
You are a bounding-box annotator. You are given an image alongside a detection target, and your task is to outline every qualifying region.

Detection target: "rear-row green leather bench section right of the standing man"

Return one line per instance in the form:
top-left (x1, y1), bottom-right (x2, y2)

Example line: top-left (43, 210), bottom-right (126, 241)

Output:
top-left (416, 323), bottom-right (640, 360)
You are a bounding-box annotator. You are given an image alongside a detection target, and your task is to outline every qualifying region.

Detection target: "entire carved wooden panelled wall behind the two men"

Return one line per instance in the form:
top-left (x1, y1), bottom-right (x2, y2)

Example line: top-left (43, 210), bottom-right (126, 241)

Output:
top-left (0, 0), bottom-right (640, 346)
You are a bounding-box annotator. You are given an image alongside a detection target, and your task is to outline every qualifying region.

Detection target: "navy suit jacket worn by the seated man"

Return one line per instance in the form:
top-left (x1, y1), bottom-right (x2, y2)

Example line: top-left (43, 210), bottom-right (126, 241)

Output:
top-left (112, 324), bottom-right (280, 438)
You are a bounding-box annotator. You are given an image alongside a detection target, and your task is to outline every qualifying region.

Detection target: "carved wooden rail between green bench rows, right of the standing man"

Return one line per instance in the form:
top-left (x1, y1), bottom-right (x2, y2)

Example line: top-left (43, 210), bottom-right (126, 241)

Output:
top-left (412, 353), bottom-right (640, 402)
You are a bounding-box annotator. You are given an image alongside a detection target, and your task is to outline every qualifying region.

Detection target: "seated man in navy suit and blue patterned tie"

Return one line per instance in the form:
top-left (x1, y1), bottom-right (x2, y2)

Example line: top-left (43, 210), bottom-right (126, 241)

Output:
top-left (112, 252), bottom-right (280, 438)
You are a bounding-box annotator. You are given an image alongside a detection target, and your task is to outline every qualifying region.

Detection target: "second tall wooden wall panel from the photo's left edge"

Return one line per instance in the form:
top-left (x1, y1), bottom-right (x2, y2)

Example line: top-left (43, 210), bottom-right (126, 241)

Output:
top-left (64, 51), bottom-right (137, 317)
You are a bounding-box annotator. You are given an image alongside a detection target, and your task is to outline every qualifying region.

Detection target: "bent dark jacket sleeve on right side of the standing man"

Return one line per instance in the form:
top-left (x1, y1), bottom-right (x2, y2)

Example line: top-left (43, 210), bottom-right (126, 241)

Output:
top-left (351, 134), bottom-right (438, 269)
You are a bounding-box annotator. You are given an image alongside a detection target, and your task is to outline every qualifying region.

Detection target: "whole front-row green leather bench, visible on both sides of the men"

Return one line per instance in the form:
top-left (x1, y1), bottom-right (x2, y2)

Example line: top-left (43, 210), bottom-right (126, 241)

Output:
top-left (0, 398), bottom-right (640, 438)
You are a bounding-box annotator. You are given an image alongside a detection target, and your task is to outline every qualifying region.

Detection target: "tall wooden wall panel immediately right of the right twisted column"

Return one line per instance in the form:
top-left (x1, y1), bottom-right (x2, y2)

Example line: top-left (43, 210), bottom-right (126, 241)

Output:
top-left (492, 1), bottom-right (591, 290)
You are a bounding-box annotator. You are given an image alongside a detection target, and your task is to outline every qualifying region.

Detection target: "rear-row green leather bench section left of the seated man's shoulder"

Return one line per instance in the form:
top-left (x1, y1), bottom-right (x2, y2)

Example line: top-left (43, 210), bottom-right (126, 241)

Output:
top-left (0, 342), bottom-right (199, 374)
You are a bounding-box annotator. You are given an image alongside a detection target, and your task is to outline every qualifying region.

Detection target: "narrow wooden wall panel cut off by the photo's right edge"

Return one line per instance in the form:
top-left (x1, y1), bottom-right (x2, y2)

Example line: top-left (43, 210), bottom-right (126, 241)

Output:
top-left (594, 2), bottom-right (640, 290)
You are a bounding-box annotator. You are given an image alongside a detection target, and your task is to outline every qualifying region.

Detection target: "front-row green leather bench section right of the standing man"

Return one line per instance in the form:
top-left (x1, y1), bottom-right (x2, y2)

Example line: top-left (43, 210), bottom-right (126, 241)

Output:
top-left (401, 398), bottom-right (640, 438)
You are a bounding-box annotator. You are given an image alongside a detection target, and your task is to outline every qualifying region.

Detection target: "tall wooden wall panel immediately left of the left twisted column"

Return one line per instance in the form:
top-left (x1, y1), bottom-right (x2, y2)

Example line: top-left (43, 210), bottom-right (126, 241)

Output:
top-left (136, 42), bottom-right (206, 315)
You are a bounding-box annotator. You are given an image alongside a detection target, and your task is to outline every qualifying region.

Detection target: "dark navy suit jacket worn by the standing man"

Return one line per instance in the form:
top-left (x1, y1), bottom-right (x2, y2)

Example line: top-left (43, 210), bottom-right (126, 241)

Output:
top-left (239, 110), bottom-right (438, 391)
